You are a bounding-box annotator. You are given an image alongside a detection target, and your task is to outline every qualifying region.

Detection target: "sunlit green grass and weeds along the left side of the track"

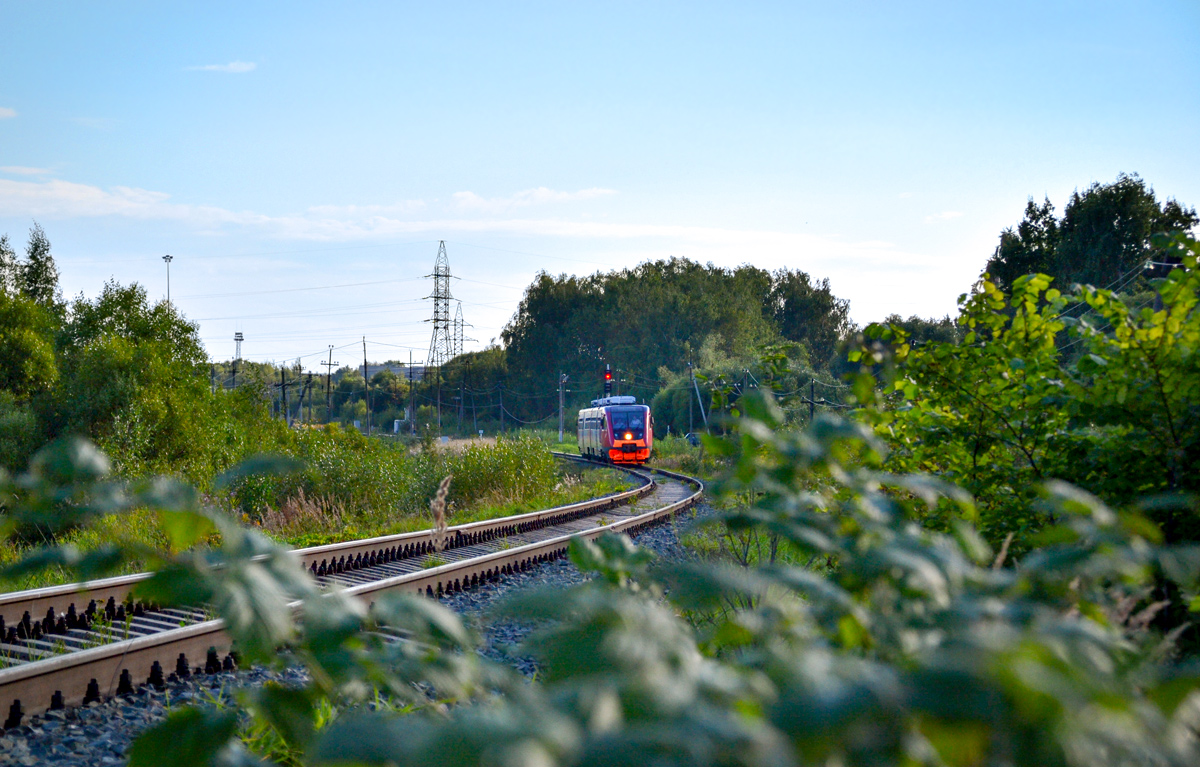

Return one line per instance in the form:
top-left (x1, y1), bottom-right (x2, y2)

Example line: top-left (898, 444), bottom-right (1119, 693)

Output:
top-left (0, 429), bottom-right (631, 591)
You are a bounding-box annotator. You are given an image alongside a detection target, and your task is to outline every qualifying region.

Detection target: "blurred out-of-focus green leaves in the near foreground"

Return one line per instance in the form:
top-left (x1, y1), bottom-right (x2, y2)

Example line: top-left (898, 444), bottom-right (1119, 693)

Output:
top-left (9, 403), bottom-right (1200, 767)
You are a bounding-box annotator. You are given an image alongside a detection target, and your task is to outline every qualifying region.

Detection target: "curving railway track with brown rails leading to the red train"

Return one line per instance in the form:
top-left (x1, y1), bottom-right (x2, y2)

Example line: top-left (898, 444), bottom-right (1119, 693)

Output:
top-left (0, 455), bottom-right (703, 729)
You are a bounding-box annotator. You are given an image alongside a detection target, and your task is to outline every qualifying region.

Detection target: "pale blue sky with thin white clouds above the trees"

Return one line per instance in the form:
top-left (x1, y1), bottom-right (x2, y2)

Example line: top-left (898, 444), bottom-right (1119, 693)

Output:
top-left (0, 2), bottom-right (1200, 365)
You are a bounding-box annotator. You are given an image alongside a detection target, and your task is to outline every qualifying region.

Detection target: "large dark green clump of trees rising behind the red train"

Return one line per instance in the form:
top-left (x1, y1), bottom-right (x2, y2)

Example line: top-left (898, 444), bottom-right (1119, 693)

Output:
top-left (503, 258), bottom-right (848, 417)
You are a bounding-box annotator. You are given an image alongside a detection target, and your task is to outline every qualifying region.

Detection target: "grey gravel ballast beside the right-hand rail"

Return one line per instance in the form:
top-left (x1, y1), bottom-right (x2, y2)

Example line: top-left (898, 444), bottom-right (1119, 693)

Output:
top-left (0, 503), bottom-right (712, 767)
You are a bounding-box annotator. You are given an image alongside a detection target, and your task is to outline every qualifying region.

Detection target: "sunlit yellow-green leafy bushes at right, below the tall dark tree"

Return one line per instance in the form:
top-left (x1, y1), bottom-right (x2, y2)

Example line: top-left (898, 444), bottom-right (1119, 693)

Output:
top-left (851, 235), bottom-right (1200, 546)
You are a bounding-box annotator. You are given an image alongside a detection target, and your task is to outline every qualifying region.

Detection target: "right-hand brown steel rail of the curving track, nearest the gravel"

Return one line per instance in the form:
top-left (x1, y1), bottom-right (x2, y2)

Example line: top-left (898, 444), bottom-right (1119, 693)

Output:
top-left (0, 456), bottom-right (703, 726)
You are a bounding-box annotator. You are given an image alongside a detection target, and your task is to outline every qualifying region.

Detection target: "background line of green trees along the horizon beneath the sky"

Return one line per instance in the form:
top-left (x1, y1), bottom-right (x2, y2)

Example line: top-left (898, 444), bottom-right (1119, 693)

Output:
top-left (0, 174), bottom-right (1198, 474)
